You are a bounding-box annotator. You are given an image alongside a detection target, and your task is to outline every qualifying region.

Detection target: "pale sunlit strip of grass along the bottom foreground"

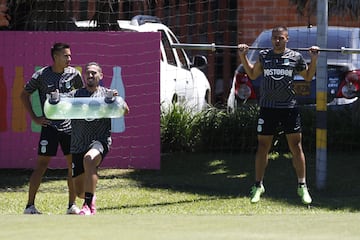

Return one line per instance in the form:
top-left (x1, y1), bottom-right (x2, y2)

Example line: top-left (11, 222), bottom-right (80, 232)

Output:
top-left (0, 213), bottom-right (360, 240)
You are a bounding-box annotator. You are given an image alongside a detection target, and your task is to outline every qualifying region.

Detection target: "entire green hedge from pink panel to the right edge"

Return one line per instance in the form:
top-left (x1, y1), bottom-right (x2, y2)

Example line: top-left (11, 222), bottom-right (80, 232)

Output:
top-left (161, 102), bottom-right (360, 153)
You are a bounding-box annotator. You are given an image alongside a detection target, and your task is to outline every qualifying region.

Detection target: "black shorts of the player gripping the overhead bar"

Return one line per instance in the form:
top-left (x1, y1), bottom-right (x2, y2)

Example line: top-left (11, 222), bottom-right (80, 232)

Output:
top-left (257, 108), bottom-right (301, 135)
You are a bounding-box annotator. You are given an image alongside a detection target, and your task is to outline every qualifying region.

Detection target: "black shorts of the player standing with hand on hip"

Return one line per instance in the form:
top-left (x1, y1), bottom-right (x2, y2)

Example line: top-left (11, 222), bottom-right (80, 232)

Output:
top-left (38, 126), bottom-right (71, 156)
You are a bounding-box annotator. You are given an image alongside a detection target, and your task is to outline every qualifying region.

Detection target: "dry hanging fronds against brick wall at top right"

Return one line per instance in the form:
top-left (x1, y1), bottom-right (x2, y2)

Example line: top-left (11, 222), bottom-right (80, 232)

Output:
top-left (289, 0), bottom-right (360, 19)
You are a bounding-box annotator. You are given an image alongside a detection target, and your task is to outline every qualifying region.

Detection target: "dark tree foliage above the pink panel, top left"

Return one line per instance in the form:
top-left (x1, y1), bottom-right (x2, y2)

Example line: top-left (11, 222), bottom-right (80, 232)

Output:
top-left (4, 0), bottom-right (120, 31)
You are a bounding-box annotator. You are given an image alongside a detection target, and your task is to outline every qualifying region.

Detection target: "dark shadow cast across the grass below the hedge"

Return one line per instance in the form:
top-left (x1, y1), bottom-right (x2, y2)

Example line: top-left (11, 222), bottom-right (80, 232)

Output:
top-left (0, 153), bottom-right (360, 212)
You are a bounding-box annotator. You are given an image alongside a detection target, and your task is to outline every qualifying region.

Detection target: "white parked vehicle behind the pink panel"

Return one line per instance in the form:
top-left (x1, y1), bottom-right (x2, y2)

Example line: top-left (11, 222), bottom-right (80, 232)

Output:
top-left (76, 15), bottom-right (211, 111)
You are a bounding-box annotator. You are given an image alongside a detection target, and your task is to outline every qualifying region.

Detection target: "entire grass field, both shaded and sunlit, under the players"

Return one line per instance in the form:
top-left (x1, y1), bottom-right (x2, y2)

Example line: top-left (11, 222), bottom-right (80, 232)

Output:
top-left (0, 153), bottom-right (360, 240)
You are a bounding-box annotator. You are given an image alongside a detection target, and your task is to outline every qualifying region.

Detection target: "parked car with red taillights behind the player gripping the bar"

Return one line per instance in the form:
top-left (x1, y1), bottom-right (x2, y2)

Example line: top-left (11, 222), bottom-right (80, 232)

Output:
top-left (227, 26), bottom-right (360, 110)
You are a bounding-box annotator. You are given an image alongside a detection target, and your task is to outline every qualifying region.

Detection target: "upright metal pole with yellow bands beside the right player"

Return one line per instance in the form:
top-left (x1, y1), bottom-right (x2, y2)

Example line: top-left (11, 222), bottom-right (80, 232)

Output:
top-left (316, 0), bottom-right (328, 190)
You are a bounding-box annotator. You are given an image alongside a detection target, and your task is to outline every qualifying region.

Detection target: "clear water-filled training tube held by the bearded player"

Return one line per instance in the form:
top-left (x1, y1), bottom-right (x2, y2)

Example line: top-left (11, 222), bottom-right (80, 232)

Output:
top-left (44, 96), bottom-right (125, 120)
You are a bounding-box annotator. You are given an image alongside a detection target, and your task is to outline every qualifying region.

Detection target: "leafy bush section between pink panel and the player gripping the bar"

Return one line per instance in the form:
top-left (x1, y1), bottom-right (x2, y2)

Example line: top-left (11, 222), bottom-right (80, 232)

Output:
top-left (161, 105), bottom-right (258, 152)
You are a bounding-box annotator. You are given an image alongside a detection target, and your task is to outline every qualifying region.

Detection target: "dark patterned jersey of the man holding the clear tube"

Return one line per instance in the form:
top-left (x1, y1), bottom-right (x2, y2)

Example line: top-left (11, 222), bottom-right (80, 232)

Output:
top-left (70, 87), bottom-right (112, 153)
